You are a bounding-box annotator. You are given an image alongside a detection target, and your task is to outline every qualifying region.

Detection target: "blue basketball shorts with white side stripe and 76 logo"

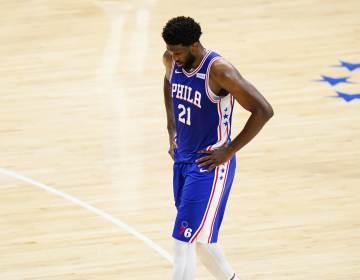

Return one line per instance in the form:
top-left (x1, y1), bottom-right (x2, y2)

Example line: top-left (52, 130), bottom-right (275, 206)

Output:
top-left (172, 156), bottom-right (236, 243)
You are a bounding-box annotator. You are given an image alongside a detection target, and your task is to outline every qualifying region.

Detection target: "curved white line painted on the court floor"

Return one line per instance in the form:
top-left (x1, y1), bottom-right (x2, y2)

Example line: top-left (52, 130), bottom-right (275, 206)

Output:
top-left (0, 168), bottom-right (173, 263)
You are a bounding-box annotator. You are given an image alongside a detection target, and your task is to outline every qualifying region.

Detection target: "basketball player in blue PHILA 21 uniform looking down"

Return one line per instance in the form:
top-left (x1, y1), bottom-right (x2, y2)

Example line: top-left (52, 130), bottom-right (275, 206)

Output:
top-left (162, 16), bottom-right (273, 280)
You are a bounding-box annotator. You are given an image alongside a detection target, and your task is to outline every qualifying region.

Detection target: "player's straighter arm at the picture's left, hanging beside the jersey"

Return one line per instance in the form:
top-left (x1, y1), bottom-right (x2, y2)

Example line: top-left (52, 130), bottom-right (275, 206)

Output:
top-left (163, 51), bottom-right (176, 159)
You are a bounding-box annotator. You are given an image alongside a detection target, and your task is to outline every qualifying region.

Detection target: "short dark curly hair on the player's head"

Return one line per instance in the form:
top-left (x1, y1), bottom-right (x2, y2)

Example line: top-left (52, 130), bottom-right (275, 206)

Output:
top-left (162, 16), bottom-right (202, 46)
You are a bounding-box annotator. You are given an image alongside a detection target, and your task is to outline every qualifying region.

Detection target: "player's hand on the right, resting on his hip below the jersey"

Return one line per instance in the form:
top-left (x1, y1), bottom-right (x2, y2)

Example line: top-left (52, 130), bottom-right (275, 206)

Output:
top-left (196, 144), bottom-right (233, 172)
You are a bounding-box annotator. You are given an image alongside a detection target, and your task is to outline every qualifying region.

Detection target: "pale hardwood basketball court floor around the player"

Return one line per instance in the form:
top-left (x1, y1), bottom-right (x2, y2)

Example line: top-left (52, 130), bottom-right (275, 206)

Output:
top-left (0, 0), bottom-right (360, 280)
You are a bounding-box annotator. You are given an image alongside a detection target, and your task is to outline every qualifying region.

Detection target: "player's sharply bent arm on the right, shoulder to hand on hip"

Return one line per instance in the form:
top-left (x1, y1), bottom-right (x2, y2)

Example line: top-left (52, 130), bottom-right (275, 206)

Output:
top-left (197, 59), bottom-right (274, 171)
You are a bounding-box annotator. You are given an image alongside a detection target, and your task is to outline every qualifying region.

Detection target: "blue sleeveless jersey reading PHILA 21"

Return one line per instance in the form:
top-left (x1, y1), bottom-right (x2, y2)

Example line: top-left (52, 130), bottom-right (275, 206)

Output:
top-left (170, 51), bottom-right (234, 163)
